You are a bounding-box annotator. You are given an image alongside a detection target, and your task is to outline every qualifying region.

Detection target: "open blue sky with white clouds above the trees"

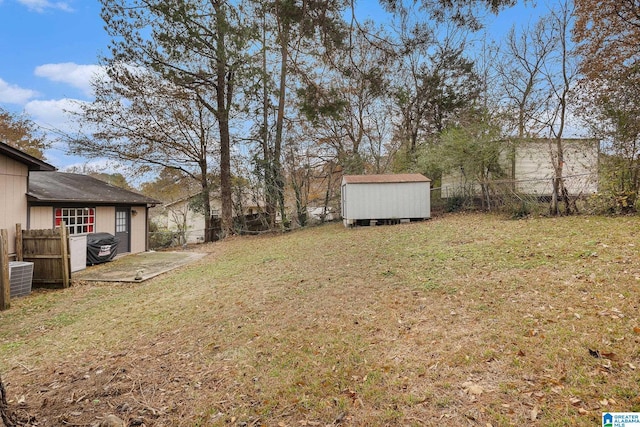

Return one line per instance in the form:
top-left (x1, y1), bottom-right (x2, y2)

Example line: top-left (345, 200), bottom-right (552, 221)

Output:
top-left (0, 0), bottom-right (546, 169)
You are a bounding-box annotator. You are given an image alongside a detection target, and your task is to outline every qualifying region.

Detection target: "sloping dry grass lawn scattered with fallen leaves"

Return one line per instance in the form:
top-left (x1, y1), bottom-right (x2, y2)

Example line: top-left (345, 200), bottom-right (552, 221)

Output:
top-left (0, 215), bottom-right (640, 427)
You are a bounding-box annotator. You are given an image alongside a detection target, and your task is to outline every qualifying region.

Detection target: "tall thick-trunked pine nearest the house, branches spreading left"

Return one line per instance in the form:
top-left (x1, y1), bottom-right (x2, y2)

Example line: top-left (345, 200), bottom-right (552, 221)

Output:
top-left (92, 0), bottom-right (255, 235)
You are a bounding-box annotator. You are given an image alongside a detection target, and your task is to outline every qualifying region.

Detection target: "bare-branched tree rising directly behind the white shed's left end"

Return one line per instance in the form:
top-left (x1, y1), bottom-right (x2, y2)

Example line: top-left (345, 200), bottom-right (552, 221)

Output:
top-left (299, 20), bottom-right (392, 174)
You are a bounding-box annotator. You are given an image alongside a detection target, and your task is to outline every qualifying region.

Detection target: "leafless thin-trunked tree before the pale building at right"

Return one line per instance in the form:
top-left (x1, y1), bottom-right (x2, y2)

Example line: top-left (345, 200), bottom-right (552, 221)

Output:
top-left (496, 1), bottom-right (577, 215)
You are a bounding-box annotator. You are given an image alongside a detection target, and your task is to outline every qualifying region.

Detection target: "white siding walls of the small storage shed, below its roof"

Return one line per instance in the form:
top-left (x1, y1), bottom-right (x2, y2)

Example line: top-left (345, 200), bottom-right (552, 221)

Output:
top-left (342, 182), bottom-right (431, 225)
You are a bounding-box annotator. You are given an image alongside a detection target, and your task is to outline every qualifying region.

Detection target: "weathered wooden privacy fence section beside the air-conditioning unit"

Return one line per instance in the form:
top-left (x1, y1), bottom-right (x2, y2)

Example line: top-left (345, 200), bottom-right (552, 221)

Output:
top-left (16, 225), bottom-right (71, 288)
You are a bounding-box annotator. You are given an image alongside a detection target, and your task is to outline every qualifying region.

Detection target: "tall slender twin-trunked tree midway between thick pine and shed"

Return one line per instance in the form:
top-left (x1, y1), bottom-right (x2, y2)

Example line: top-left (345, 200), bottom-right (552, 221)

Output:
top-left (251, 0), bottom-right (345, 231)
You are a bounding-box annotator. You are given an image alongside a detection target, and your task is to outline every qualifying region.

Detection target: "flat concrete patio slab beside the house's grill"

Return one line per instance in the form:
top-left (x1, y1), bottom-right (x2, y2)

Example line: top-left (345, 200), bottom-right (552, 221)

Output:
top-left (72, 252), bottom-right (206, 282)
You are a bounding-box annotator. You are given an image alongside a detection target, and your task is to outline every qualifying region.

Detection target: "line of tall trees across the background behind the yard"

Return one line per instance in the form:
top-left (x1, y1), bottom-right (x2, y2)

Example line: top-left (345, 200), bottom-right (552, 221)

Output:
top-left (0, 0), bottom-right (640, 239)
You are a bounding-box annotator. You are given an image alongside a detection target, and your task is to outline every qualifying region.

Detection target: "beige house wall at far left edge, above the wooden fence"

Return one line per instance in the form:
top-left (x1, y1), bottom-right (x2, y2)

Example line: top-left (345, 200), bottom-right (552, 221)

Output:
top-left (0, 154), bottom-right (29, 257)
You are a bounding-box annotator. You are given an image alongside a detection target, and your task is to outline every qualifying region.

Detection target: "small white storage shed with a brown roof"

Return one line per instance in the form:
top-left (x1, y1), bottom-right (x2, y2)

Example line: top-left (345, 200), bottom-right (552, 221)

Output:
top-left (342, 174), bottom-right (431, 227)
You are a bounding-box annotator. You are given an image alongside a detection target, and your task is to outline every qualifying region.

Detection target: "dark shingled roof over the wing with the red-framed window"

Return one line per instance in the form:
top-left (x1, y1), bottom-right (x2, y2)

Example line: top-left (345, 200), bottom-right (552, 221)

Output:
top-left (27, 172), bottom-right (160, 205)
